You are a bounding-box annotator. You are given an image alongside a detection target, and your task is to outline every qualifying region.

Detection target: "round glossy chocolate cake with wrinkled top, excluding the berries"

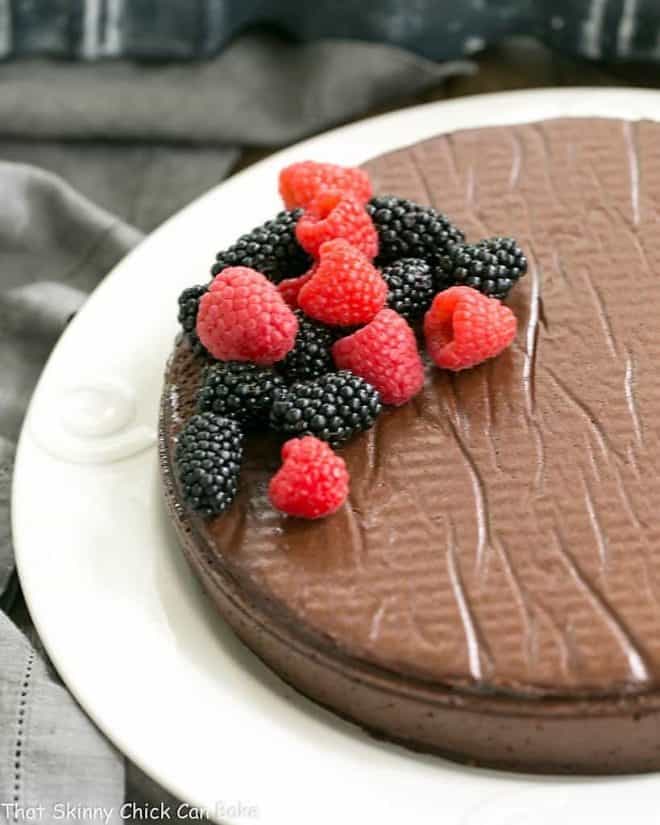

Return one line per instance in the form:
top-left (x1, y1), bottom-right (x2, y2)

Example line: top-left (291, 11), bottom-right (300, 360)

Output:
top-left (161, 119), bottom-right (660, 773)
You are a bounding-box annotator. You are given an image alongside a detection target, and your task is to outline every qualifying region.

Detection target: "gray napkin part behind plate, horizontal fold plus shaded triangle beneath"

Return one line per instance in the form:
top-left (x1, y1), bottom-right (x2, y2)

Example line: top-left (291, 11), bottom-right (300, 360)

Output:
top-left (0, 33), bottom-right (473, 230)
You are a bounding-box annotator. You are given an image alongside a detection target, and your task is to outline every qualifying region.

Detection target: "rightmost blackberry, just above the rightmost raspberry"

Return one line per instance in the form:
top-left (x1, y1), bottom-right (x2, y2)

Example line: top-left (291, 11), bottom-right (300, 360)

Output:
top-left (438, 237), bottom-right (527, 299)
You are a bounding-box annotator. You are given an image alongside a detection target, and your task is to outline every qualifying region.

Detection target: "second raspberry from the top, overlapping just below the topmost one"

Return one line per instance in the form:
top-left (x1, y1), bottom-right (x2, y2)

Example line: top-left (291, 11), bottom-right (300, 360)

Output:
top-left (296, 189), bottom-right (378, 259)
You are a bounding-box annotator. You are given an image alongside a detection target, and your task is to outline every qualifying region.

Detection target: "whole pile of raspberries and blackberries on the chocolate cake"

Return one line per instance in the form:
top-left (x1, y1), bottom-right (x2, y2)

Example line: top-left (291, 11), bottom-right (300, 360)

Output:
top-left (175, 161), bottom-right (527, 519)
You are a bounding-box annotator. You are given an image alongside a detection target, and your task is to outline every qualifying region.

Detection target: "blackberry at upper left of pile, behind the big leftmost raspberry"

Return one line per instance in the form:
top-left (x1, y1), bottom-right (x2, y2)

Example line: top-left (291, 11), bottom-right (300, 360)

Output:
top-left (211, 209), bottom-right (312, 283)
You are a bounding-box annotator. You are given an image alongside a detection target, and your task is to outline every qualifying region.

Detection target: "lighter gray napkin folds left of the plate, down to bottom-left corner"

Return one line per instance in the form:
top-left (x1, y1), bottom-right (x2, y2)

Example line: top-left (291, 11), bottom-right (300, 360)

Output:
top-left (0, 162), bottom-right (141, 822)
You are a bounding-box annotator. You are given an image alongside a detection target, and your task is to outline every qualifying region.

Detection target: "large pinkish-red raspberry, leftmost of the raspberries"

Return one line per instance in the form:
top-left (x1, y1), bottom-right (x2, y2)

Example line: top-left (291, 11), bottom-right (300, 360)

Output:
top-left (197, 266), bottom-right (298, 366)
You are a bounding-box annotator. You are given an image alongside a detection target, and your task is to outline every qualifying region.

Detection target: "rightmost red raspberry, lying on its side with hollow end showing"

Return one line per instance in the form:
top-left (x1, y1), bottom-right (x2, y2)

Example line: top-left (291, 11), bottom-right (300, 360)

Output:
top-left (424, 286), bottom-right (516, 371)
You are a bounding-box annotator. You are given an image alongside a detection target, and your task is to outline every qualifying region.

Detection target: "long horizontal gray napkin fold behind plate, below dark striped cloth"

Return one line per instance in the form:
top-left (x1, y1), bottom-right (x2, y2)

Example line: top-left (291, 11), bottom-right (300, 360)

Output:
top-left (0, 33), bottom-right (474, 146)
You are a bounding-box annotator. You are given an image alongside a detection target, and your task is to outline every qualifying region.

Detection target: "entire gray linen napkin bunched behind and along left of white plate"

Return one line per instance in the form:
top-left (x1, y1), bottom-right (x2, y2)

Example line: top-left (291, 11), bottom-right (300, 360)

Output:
top-left (0, 33), bottom-right (466, 823)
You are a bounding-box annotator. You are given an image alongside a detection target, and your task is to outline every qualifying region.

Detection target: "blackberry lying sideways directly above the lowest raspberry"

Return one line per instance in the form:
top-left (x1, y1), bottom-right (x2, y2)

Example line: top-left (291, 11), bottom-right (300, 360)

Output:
top-left (270, 370), bottom-right (381, 446)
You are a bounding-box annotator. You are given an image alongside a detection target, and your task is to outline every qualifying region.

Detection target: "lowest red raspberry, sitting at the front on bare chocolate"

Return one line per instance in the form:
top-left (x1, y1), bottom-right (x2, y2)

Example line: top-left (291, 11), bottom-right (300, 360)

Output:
top-left (268, 435), bottom-right (349, 518)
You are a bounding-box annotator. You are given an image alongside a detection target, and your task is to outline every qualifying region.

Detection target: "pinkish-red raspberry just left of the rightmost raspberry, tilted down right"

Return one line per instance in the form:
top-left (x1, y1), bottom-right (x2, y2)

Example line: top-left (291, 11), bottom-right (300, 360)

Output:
top-left (332, 309), bottom-right (424, 407)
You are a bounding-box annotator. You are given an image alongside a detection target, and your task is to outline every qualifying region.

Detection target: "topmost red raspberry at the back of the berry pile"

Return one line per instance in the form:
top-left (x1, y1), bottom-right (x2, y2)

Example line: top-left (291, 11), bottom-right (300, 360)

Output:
top-left (280, 160), bottom-right (371, 209)
